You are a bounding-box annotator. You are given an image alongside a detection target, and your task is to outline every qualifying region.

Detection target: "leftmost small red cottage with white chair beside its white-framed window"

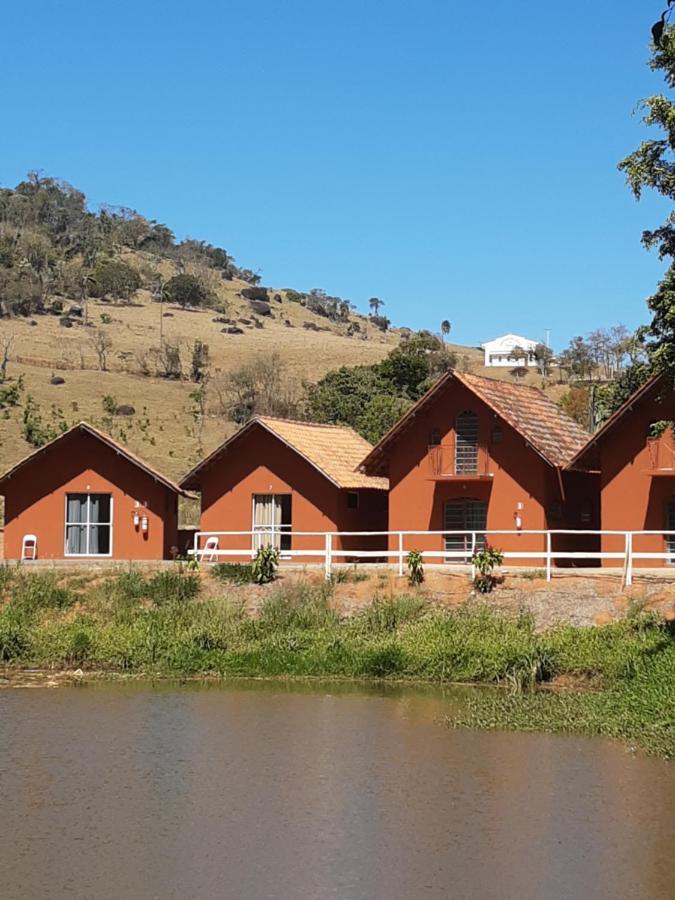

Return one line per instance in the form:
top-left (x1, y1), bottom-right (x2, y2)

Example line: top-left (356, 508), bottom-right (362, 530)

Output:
top-left (0, 422), bottom-right (183, 560)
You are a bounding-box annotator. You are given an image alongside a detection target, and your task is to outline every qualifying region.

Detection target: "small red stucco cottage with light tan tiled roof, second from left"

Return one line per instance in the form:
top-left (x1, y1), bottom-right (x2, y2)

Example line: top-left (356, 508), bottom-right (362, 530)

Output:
top-left (181, 416), bottom-right (387, 562)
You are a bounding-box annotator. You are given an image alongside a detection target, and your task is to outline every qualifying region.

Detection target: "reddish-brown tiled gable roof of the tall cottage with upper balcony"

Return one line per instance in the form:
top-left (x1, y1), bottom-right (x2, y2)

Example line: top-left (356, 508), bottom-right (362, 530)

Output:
top-left (361, 369), bottom-right (589, 473)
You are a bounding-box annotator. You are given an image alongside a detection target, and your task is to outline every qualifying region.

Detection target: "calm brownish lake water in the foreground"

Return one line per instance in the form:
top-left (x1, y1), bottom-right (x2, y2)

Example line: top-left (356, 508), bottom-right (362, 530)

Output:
top-left (0, 683), bottom-right (675, 900)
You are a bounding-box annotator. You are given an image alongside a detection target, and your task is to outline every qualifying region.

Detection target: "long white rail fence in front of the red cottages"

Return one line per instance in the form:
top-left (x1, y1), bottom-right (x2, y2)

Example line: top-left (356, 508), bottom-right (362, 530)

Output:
top-left (189, 526), bottom-right (675, 585)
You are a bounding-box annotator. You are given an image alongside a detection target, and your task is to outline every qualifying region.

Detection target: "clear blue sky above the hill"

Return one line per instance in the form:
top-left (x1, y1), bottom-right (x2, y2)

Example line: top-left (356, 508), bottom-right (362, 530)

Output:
top-left (0, 0), bottom-right (665, 348)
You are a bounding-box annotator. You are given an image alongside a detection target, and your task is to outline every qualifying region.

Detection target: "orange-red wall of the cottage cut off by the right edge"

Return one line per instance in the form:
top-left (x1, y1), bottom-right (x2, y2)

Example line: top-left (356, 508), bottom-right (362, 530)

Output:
top-left (599, 389), bottom-right (675, 567)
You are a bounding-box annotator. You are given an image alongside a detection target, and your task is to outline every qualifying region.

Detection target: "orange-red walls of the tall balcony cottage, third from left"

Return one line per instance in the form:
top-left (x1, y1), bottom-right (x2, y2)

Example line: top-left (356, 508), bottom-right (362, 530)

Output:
top-left (382, 382), bottom-right (598, 566)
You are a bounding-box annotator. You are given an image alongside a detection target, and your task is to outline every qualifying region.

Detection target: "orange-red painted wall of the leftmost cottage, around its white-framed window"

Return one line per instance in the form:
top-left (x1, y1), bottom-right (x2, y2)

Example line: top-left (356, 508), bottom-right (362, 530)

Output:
top-left (3, 432), bottom-right (178, 560)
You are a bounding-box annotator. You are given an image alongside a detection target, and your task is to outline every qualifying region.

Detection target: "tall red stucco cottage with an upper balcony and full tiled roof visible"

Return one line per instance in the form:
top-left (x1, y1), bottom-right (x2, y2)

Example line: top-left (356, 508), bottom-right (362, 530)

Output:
top-left (361, 371), bottom-right (598, 565)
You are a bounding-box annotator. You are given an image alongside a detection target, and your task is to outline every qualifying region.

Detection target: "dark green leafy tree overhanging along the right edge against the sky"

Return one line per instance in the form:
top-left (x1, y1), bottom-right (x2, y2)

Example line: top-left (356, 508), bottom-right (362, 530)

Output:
top-left (619, 16), bottom-right (675, 374)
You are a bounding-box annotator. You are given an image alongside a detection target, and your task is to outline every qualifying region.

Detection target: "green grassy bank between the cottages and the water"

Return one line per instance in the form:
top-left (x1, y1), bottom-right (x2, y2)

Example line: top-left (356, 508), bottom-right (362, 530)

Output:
top-left (0, 567), bottom-right (675, 758)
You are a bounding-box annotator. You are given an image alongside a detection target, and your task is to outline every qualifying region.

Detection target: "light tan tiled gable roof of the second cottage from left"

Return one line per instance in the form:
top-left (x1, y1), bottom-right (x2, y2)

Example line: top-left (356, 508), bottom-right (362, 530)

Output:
top-left (181, 416), bottom-right (389, 491)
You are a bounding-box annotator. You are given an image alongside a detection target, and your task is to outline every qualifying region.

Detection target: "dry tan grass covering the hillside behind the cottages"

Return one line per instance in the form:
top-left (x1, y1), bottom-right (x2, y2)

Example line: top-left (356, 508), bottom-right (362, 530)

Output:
top-left (0, 254), bottom-right (564, 486)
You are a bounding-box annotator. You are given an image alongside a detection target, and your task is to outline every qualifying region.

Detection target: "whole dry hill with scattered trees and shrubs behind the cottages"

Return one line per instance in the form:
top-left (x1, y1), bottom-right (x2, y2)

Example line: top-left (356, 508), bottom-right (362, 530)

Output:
top-left (0, 174), bottom-right (560, 492)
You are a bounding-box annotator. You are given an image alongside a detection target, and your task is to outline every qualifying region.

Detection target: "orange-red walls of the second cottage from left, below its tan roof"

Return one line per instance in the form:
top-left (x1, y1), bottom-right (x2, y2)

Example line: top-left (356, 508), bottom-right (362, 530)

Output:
top-left (195, 426), bottom-right (387, 562)
